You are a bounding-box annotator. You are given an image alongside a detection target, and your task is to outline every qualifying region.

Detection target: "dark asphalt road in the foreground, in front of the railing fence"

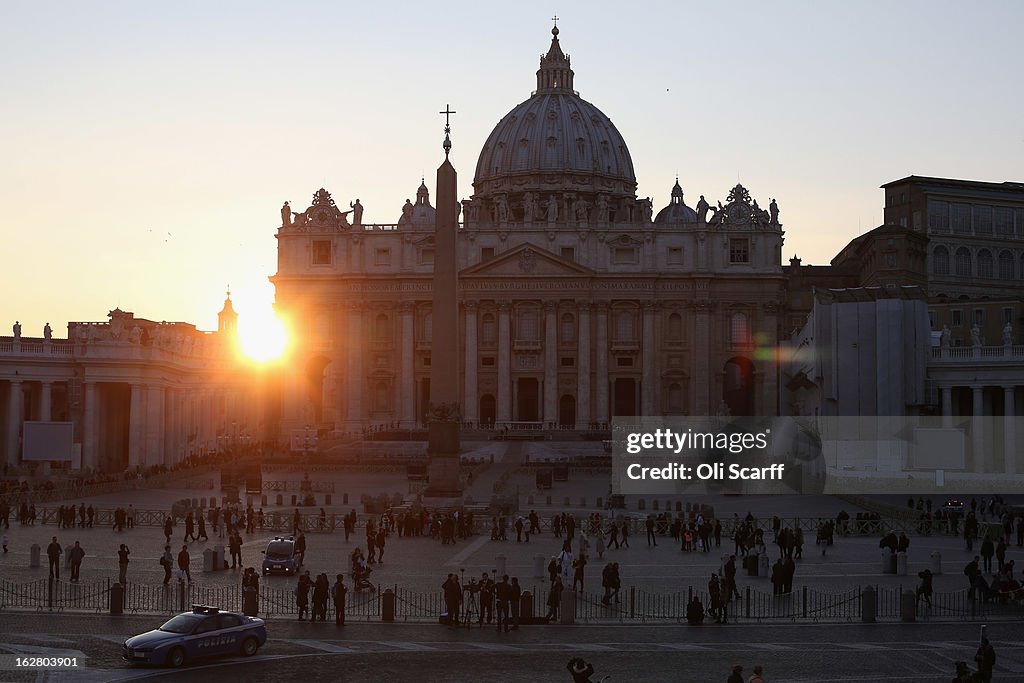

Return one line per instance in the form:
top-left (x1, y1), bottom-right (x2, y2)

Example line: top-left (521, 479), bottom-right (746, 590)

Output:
top-left (0, 613), bottom-right (1024, 683)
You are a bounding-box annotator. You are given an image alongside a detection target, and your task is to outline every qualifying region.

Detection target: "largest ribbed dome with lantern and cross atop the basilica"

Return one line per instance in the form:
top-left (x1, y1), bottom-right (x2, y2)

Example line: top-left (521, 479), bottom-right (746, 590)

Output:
top-left (473, 28), bottom-right (637, 222)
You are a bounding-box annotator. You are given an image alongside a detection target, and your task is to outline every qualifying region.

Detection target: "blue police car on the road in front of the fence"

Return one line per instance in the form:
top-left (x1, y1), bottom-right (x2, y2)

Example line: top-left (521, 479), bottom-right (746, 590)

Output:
top-left (121, 605), bottom-right (266, 667)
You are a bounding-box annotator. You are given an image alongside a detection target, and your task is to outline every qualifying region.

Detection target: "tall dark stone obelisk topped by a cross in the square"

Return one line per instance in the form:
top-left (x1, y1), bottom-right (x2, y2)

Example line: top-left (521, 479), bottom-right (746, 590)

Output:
top-left (426, 106), bottom-right (462, 498)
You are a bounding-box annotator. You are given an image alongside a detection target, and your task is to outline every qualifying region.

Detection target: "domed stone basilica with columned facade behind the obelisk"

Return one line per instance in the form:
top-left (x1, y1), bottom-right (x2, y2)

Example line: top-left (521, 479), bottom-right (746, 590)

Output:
top-left (271, 28), bottom-right (787, 433)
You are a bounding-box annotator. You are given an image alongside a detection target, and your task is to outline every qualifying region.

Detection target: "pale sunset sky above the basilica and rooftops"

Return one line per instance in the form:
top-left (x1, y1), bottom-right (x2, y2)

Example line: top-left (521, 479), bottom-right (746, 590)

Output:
top-left (0, 0), bottom-right (1024, 337)
